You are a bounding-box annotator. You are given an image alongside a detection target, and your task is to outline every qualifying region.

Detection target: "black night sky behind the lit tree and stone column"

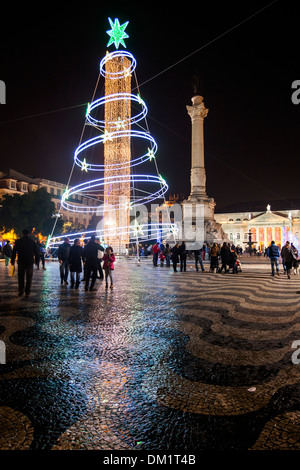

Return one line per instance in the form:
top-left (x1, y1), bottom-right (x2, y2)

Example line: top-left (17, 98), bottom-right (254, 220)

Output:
top-left (0, 0), bottom-right (300, 207)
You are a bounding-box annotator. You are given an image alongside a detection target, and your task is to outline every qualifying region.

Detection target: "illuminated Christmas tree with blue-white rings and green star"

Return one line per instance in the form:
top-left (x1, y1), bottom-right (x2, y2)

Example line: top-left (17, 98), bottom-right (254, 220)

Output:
top-left (49, 18), bottom-right (172, 254)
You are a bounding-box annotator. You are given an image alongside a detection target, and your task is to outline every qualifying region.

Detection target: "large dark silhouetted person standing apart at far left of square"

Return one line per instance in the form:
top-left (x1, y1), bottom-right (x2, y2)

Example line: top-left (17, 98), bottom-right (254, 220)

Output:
top-left (10, 229), bottom-right (39, 297)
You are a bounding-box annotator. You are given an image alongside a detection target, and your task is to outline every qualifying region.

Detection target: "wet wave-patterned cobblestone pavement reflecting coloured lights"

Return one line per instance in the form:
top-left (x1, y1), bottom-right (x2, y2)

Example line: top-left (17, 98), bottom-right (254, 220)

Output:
top-left (0, 259), bottom-right (300, 452)
